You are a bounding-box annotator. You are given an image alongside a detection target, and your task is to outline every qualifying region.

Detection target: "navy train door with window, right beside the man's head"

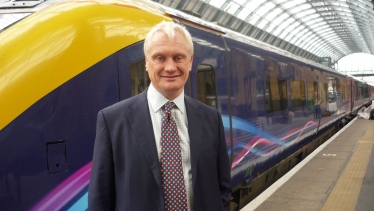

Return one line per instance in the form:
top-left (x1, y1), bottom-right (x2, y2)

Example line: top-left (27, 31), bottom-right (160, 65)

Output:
top-left (180, 24), bottom-right (232, 160)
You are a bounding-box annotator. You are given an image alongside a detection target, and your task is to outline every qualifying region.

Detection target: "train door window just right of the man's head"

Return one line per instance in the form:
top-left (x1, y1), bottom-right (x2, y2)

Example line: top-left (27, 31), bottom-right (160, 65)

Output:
top-left (197, 64), bottom-right (217, 108)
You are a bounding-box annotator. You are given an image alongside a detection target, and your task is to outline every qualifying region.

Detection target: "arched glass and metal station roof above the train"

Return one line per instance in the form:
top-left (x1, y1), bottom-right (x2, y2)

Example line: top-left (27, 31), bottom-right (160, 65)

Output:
top-left (154, 0), bottom-right (374, 65)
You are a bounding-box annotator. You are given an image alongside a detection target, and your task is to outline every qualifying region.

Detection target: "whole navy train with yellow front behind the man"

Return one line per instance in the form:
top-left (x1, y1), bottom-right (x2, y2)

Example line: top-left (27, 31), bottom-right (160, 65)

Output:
top-left (0, 0), bottom-right (374, 211)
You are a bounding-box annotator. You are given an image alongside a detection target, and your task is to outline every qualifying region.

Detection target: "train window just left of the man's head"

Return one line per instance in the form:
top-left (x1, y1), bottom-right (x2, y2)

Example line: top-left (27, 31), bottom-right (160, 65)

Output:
top-left (130, 58), bottom-right (151, 96)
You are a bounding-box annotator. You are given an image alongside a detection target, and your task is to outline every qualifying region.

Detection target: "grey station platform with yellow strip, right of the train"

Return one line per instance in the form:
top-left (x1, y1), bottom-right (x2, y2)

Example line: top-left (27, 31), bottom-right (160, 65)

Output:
top-left (241, 111), bottom-right (374, 211)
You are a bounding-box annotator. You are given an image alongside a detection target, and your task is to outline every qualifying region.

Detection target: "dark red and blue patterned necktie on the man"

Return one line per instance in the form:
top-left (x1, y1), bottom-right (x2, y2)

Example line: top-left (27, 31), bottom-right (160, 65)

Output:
top-left (161, 101), bottom-right (188, 211)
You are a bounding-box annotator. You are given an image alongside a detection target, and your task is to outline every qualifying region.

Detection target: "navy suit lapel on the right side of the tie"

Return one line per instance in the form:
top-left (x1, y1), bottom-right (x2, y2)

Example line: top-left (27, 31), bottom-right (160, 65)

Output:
top-left (184, 96), bottom-right (204, 184)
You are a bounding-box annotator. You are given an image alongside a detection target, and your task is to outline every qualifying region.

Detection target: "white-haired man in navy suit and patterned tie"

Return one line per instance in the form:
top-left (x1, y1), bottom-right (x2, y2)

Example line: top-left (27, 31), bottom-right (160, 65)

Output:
top-left (88, 22), bottom-right (231, 211)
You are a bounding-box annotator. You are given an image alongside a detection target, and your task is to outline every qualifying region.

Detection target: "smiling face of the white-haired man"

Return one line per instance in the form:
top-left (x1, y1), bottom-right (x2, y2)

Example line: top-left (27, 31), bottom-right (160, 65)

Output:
top-left (145, 32), bottom-right (193, 100)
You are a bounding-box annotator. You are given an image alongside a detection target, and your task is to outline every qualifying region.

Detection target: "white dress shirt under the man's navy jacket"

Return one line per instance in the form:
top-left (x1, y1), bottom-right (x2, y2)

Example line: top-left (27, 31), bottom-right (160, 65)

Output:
top-left (147, 83), bottom-right (193, 211)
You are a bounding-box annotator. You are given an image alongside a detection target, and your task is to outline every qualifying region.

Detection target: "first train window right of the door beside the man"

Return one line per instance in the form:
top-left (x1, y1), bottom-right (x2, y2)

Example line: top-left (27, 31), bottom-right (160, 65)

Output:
top-left (265, 77), bottom-right (288, 113)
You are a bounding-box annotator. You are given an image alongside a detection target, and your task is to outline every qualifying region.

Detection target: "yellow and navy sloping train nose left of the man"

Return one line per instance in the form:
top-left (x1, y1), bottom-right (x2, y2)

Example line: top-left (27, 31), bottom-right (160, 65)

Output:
top-left (0, 1), bottom-right (171, 210)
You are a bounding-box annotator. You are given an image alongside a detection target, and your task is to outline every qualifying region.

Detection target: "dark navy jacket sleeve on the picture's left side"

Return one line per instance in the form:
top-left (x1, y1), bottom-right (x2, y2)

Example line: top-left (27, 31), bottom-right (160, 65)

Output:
top-left (88, 111), bottom-right (116, 211)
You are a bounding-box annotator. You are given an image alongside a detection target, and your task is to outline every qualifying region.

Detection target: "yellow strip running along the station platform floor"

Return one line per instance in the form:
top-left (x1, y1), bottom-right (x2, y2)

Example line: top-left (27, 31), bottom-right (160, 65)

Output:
top-left (322, 121), bottom-right (374, 211)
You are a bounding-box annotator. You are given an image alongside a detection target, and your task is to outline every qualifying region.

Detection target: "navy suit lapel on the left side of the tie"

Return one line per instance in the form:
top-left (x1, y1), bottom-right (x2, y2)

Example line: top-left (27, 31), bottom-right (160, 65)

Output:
top-left (128, 90), bottom-right (162, 188)
